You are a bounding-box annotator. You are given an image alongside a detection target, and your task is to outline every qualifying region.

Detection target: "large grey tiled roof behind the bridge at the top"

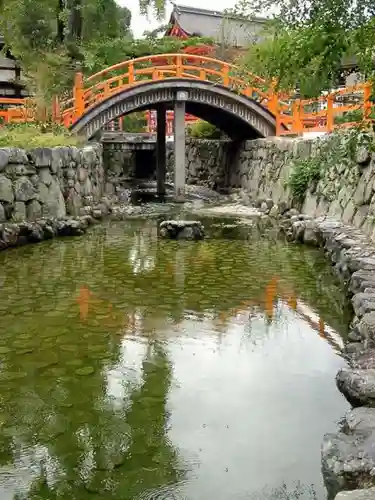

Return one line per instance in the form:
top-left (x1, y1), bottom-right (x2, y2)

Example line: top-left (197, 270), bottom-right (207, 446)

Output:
top-left (170, 4), bottom-right (266, 47)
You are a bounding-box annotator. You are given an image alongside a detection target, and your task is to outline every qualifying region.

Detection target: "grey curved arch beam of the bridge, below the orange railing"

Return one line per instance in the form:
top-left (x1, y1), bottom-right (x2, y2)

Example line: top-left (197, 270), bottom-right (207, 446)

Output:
top-left (71, 78), bottom-right (276, 139)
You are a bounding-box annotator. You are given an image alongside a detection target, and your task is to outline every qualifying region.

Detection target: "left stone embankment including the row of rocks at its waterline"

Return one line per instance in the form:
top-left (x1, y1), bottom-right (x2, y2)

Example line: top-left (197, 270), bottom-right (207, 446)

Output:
top-left (0, 144), bottom-right (107, 250)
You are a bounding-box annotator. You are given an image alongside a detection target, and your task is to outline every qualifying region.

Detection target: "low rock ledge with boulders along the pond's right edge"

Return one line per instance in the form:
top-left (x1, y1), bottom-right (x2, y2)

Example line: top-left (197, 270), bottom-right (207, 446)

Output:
top-left (272, 212), bottom-right (375, 500)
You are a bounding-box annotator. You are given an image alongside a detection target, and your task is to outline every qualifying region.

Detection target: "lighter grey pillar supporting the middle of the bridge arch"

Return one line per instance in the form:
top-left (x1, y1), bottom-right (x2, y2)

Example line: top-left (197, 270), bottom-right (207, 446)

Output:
top-left (174, 91), bottom-right (186, 201)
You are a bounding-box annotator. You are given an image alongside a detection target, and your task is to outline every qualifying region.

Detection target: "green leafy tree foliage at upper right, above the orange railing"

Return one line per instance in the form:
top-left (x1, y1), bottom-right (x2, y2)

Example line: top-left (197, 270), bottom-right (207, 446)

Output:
top-left (229, 0), bottom-right (375, 96)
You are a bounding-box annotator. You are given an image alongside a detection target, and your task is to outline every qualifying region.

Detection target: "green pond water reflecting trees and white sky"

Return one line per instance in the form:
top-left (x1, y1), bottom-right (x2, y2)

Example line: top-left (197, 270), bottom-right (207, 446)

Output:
top-left (0, 221), bottom-right (348, 500)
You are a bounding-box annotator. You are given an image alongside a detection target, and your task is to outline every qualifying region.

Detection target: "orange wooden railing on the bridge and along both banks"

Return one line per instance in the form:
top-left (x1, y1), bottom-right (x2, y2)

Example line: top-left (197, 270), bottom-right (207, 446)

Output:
top-left (0, 54), bottom-right (373, 135)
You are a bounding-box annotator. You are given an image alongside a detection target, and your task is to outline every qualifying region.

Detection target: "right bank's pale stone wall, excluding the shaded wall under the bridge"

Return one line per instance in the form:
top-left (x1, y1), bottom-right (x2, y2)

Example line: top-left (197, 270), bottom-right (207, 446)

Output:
top-left (235, 139), bottom-right (375, 241)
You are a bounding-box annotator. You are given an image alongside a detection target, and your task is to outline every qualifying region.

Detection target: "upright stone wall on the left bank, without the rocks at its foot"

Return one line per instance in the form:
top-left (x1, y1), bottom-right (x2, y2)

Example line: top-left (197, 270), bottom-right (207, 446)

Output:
top-left (0, 144), bottom-right (104, 222)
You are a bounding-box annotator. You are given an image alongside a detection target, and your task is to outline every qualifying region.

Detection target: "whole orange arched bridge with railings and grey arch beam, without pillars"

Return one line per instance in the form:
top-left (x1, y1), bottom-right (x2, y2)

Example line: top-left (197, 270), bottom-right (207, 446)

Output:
top-left (0, 54), bottom-right (373, 138)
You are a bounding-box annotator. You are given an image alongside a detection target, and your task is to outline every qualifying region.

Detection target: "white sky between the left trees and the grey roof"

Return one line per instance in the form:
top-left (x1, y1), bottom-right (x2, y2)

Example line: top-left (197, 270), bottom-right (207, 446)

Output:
top-left (117, 0), bottom-right (236, 37)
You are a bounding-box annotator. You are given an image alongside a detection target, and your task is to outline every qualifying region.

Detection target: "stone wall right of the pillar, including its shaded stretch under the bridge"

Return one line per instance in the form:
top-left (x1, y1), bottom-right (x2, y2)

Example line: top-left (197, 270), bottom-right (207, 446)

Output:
top-left (186, 138), bottom-right (375, 241)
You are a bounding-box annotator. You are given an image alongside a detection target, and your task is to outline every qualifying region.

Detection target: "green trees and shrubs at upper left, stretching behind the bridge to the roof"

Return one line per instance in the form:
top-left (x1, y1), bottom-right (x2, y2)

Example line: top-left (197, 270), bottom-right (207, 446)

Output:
top-left (0, 0), bottom-right (214, 102)
